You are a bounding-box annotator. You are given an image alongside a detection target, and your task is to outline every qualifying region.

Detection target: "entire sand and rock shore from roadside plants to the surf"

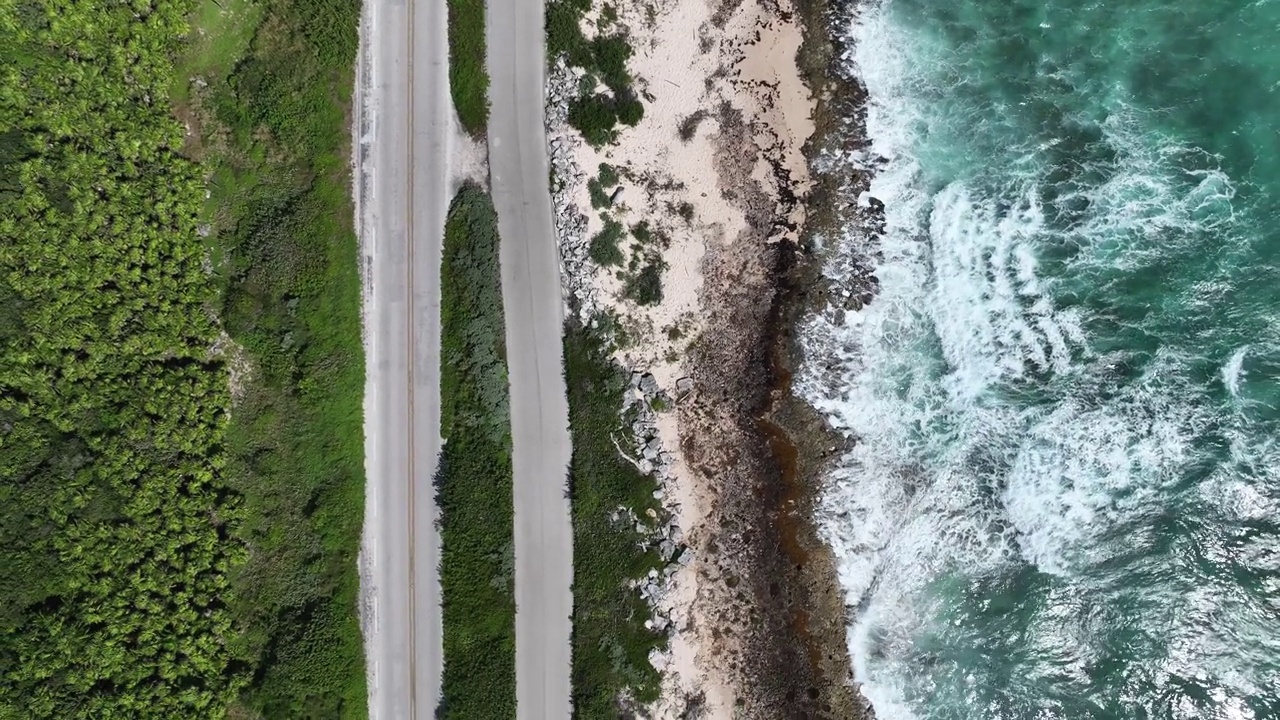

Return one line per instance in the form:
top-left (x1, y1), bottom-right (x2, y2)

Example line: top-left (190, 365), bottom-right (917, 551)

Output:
top-left (547, 0), bottom-right (872, 719)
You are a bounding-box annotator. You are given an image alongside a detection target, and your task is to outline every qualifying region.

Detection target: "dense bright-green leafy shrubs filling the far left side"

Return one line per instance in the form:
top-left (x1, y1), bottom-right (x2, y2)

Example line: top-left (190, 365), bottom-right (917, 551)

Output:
top-left (0, 0), bottom-right (246, 720)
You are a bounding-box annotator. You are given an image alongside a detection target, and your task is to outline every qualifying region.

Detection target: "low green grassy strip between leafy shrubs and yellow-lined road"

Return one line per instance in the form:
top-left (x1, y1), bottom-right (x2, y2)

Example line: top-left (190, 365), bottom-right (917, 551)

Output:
top-left (177, 0), bottom-right (367, 719)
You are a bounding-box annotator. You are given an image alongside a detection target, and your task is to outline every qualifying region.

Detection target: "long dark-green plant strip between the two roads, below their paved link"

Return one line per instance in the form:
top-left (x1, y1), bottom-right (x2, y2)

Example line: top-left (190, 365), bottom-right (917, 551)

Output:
top-left (435, 186), bottom-right (516, 720)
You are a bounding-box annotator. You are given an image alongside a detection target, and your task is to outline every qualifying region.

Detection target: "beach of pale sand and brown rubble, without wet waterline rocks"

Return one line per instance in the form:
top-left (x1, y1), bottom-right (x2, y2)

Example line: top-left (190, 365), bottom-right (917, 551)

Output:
top-left (549, 0), bottom-right (865, 719)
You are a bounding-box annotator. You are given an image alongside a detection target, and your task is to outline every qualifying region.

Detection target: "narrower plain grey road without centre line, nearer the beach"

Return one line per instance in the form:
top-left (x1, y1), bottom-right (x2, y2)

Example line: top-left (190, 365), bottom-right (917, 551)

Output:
top-left (486, 0), bottom-right (573, 720)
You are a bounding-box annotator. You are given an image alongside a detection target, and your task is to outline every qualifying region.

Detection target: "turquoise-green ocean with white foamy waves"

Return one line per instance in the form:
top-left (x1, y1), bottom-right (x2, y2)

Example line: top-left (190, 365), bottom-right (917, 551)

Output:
top-left (797, 0), bottom-right (1280, 720)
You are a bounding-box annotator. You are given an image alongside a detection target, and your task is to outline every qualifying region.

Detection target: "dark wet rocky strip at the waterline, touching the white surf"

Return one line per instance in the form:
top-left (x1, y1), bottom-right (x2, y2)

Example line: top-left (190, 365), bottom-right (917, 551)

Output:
top-left (772, 0), bottom-right (884, 720)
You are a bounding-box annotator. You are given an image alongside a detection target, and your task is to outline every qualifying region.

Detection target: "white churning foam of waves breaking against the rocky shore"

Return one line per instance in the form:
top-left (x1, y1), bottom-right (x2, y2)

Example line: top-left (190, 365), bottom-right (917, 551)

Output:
top-left (796, 0), bottom-right (1243, 720)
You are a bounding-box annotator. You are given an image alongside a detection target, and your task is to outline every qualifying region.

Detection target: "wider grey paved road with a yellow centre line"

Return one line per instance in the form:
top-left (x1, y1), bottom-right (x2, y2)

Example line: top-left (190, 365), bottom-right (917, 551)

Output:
top-left (361, 0), bottom-right (453, 720)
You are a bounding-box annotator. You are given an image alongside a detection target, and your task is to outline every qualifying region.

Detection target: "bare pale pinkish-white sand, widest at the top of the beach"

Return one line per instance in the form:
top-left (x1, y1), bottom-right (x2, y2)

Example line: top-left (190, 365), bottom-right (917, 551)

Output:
top-left (552, 0), bottom-right (813, 717)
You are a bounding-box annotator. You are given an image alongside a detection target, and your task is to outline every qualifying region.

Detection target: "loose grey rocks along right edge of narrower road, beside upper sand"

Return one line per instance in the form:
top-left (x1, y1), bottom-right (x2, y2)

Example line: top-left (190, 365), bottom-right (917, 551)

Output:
top-left (547, 58), bottom-right (599, 322)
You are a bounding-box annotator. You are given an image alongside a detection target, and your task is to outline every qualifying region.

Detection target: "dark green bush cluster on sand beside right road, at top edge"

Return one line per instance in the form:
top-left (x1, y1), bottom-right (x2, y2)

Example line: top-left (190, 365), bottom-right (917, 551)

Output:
top-left (547, 0), bottom-right (644, 146)
